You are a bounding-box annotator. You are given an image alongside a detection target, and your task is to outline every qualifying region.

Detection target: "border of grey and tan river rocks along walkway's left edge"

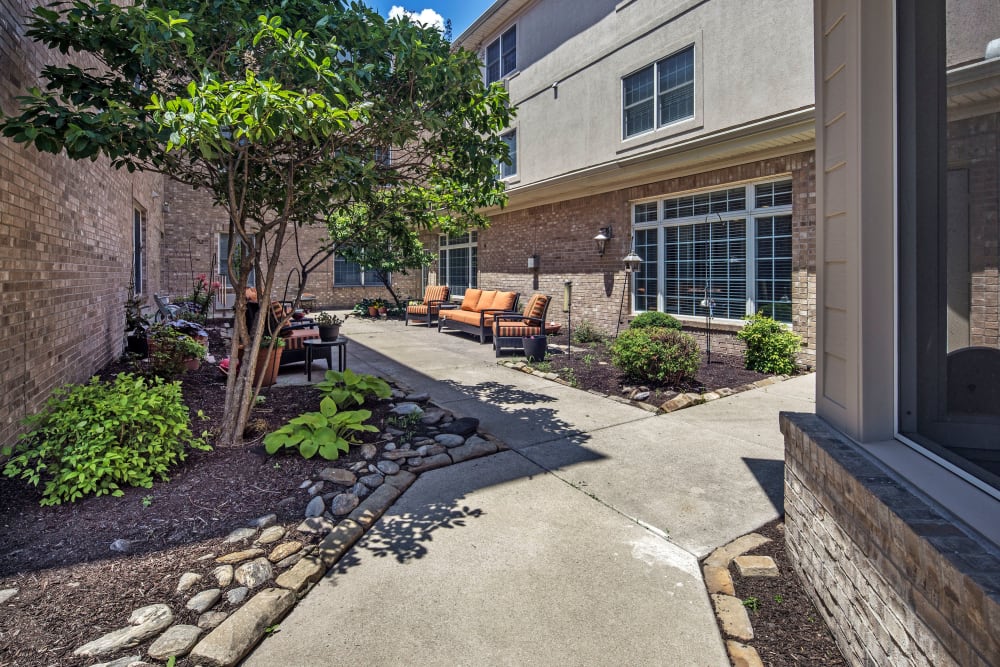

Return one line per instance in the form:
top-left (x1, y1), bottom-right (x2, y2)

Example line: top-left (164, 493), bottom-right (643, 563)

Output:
top-left (74, 389), bottom-right (507, 667)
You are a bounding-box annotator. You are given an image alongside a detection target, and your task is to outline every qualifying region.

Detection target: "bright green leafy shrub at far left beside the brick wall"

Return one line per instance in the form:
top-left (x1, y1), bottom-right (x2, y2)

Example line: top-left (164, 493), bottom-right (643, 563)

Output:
top-left (3, 373), bottom-right (210, 505)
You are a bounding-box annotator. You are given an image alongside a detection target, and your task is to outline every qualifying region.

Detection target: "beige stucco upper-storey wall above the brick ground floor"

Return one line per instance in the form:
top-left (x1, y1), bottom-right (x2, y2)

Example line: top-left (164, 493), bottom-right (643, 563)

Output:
top-left (474, 0), bottom-right (813, 186)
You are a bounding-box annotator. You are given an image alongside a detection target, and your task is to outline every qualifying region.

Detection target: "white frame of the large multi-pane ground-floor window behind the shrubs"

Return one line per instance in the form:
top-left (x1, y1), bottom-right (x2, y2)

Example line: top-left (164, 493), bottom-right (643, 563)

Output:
top-left (630, 174), bottom-right (795, 325)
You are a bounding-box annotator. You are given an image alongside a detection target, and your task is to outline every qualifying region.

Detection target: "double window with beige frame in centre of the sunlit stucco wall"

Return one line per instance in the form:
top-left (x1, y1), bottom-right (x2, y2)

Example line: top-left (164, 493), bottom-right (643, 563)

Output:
top-left (622, 46), bottom-right (694, 138)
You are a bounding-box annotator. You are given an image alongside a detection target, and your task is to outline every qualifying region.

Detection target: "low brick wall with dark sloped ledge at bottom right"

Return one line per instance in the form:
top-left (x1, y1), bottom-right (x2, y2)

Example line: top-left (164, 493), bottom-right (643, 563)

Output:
top-left (781, 414), bottom-right (1000, 667)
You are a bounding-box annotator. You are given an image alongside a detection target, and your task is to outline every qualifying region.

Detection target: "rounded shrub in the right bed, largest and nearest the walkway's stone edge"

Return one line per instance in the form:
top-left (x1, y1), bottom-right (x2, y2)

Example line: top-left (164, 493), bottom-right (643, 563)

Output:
top-left (611, 327), bottom-right (701, 384)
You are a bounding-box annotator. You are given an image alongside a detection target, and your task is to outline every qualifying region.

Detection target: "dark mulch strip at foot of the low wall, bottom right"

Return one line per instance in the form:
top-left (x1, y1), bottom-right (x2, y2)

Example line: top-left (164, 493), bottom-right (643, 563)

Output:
top-left (732, 519), bottom-right (848, 667)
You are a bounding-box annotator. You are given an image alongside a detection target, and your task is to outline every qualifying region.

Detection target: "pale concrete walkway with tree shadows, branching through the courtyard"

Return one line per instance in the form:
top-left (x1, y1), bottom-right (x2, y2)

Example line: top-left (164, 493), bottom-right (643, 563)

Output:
top-left (244, 319), bottom-right (814, 667)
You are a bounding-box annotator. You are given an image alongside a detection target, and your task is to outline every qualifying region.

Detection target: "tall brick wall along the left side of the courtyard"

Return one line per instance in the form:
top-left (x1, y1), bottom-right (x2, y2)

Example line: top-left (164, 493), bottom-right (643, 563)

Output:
top-left (0, 0), bottom-right (163, 445)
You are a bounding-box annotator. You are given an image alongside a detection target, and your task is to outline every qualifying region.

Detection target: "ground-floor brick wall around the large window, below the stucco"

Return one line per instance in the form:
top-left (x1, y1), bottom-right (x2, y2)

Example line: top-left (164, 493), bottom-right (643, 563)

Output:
top-left (479, 151), bottom-right (816, 367)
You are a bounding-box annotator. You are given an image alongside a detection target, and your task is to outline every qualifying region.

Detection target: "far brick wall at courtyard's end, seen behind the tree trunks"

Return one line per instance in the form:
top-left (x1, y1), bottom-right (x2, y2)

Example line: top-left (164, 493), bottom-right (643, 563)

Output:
top-left (163, 182), bottom-right (414, 316)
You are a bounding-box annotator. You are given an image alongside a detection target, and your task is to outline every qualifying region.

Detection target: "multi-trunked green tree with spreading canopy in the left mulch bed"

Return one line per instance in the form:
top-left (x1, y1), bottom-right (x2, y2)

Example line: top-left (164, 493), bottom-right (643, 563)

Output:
top-left (0, 0), bottom-right (511, 443)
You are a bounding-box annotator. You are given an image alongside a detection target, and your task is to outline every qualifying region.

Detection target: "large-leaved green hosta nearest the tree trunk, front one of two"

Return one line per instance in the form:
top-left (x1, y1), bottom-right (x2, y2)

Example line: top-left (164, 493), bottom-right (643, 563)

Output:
top-left (264, 396), bottom-right (378, 461)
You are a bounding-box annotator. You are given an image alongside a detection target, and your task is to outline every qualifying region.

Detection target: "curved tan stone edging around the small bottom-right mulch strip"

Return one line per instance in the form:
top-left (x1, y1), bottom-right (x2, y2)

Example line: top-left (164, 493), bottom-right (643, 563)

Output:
top-left (702, 533), bottom-right (771, 667)
